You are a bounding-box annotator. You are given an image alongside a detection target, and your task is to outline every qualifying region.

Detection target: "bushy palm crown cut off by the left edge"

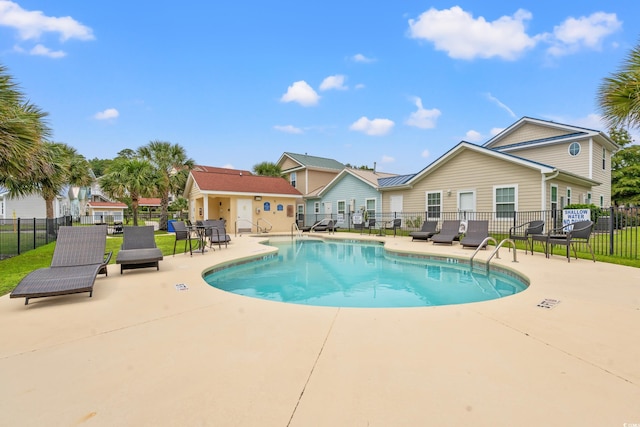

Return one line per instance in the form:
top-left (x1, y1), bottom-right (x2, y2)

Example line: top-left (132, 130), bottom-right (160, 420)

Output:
top-left (0, 65), bottom-right (51, 195)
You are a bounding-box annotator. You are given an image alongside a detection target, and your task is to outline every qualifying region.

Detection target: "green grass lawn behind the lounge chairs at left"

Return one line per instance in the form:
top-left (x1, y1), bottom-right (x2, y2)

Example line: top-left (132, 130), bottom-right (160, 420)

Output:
top-left (0, 232), bottom-right (184, 296)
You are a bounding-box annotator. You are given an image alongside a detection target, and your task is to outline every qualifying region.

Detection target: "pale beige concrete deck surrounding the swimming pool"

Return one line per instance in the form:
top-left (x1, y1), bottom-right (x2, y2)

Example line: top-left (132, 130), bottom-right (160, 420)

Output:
top-left (0, 233), bottom-right (640, 427)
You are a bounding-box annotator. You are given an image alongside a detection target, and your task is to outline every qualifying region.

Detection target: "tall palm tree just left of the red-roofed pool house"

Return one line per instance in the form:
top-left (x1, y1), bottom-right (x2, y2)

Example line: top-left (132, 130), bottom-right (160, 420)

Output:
top-left (138, 141), bottom-right (194, 230)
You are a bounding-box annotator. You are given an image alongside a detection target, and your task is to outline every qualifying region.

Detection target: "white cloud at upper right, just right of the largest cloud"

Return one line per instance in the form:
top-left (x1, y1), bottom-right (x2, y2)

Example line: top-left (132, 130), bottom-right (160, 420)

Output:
top-left (547, 12), bottom-right (622, 56)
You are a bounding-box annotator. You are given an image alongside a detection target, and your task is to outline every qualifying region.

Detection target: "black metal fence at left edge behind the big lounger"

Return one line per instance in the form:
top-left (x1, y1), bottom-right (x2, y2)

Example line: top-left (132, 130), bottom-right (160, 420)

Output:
top-left (0, 216), bottom-right (71, 259)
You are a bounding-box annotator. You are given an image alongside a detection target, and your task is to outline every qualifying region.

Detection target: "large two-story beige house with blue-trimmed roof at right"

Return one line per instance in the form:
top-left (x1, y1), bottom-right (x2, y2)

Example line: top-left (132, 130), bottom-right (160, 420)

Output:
top-left (379, 118), bottom-right (618, 221)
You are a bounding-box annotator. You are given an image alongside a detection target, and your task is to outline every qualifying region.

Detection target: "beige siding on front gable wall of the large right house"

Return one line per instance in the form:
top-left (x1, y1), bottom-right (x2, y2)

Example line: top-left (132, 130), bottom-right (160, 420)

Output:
top-left (392, 150), bottom-right (542, 212)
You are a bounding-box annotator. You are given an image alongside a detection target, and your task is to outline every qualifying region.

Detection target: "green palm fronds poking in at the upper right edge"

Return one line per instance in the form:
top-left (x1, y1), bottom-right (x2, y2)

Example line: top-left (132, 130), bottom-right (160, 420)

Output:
top-left (598, 45), bottom-right (640, 132)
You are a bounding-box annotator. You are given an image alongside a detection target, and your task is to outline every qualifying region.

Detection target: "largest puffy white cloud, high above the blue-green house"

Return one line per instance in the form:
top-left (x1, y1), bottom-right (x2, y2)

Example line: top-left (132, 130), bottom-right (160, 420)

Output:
top-left (409, 6), bottom-right (537, 60)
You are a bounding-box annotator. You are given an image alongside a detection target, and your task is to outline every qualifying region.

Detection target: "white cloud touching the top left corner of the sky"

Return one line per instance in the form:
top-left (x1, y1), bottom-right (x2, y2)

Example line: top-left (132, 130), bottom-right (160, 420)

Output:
top-left (0, 0), bottom-right (94, 41)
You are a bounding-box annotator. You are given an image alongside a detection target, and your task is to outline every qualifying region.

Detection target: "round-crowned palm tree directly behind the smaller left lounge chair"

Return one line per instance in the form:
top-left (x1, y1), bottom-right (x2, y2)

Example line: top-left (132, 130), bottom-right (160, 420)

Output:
top-left (99, 157), bottom-right (158, 226)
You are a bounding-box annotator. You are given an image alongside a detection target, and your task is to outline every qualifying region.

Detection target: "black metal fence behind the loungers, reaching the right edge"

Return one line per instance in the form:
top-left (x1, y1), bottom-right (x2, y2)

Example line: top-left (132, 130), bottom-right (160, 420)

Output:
top-left (298, 207), bottom-right (640, 260)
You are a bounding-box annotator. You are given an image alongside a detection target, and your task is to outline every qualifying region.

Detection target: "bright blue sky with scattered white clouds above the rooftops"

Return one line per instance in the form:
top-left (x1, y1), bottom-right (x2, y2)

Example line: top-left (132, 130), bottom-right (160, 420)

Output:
top-left (0, 0), bottom-right (640, 174)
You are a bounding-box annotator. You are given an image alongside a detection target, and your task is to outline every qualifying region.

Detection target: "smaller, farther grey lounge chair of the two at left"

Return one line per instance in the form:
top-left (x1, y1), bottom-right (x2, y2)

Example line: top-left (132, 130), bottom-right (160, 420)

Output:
top-left (116, 225), bottom-right (162, 274)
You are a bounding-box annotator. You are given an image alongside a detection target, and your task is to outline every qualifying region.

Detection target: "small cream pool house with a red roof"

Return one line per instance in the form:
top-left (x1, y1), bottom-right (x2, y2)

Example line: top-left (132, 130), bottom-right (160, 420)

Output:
top-left (184, 166), bottom-right (302, 233)
